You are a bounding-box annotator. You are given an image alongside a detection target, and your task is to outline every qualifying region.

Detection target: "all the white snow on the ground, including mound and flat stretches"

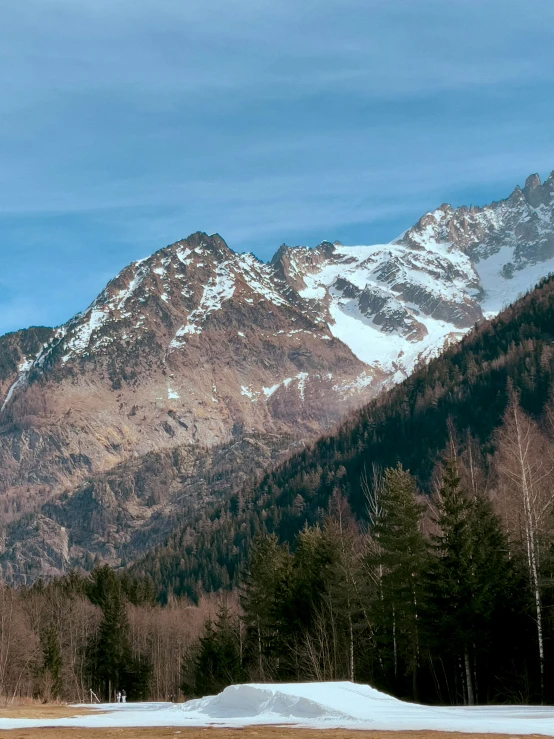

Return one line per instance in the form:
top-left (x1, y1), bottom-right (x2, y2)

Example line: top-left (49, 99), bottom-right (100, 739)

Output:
top-left (0, 682), bottom-right (554, 736)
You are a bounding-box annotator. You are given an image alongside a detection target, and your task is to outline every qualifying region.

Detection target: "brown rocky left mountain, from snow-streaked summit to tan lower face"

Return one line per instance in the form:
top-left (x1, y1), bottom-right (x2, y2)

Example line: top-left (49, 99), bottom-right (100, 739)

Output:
top-left (0, 234), bottom-right (366, 516)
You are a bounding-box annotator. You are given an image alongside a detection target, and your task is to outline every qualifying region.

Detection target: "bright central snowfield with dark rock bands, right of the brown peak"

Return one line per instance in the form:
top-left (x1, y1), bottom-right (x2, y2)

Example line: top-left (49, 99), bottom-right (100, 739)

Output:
top-left (274, 244), bottom-right (481, 380)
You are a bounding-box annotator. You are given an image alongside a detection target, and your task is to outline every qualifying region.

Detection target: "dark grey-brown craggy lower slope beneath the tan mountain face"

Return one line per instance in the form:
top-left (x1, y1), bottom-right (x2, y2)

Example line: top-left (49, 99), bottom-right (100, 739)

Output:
top-left (0, 434), bottom-right (302, 584)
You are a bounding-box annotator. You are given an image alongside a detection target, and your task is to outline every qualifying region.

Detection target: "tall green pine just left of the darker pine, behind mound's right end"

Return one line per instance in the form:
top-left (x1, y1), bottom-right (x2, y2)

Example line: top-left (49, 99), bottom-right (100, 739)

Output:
top-left (368, 464), bottom-right (428, 699)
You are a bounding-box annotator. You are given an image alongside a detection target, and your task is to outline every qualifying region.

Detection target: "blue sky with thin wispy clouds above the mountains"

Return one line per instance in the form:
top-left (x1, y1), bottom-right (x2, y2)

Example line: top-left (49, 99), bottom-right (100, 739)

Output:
top-left (0, 0), bottom-right (554, 333)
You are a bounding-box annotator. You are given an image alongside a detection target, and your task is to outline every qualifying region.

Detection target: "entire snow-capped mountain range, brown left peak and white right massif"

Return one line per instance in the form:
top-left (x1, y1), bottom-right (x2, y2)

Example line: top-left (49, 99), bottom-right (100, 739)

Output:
top-left (0, 173), bottom-right (554, 568)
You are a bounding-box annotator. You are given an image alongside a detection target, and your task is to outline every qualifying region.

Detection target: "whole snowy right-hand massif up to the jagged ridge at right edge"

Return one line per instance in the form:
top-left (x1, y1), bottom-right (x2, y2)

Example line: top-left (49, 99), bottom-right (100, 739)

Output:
top-left (273, 173), bottom-right (554, 382)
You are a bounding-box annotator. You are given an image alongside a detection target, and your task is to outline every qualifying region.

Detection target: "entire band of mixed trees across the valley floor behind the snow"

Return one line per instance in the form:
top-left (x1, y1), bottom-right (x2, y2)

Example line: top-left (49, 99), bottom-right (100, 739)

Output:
top-left (0, 389), bottom-right (554, 705)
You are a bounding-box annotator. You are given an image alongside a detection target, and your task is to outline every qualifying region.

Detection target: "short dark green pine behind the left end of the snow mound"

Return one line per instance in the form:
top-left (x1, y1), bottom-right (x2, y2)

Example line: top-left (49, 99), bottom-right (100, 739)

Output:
top-left (188, 603), bottom-right (246, 695)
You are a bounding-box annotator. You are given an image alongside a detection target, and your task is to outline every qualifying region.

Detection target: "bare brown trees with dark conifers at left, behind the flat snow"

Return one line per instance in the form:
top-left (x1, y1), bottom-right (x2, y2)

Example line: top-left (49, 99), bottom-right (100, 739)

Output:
top-left (0, 565), bottom-right (216, 702)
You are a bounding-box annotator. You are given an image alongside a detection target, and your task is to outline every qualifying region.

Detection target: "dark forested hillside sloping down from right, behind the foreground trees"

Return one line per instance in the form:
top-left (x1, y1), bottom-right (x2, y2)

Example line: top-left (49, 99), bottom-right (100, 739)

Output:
top-left (135, 278), bottom-right (554, 598)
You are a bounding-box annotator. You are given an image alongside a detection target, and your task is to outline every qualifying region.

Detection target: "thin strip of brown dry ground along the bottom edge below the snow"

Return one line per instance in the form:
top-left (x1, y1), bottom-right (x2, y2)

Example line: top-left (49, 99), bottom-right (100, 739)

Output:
top-left (0, 728), bottom-right (538, 739)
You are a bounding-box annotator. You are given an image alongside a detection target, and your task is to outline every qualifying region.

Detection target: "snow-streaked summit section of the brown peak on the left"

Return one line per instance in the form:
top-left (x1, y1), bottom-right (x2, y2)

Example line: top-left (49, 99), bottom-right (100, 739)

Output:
top-left (45, 233), bottom-right (306, 363)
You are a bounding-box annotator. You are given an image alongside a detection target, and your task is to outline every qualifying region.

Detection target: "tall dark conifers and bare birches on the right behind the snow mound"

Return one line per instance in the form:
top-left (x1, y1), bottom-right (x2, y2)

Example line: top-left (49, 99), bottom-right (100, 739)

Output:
top-left (182, 396), bottom-right (554, 705)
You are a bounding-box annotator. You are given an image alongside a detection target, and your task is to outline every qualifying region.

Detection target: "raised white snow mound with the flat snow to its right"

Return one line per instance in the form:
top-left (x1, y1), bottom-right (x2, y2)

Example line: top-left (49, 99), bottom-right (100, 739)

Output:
top-left (178, 682), bottom-right (554, 736)
